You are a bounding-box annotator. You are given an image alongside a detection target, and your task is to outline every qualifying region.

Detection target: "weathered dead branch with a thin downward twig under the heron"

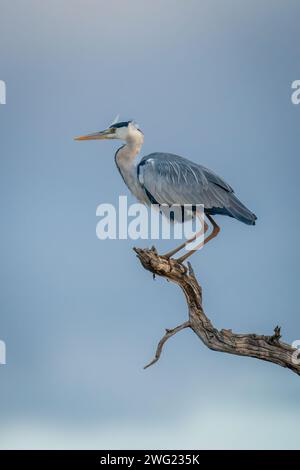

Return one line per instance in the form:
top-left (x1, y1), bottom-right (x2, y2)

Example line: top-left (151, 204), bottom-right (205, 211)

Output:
top-left (134, 248), bottom-right (300, 375)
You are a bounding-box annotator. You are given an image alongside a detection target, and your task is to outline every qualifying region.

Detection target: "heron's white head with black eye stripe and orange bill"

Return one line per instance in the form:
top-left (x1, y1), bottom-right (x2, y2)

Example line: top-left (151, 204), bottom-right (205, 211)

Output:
top-left (75, 121), bottom-right (143, 142)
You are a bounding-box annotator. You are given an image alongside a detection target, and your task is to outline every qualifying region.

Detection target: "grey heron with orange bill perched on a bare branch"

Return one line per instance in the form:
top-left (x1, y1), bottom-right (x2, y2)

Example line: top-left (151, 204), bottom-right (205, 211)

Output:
top-left (75, 121), bottom-right (257, 262)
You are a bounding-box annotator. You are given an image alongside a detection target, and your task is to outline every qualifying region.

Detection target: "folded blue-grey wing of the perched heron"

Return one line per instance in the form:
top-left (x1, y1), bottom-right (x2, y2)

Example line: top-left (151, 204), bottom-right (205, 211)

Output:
top-left (138, 153), bottom-right (233, 209)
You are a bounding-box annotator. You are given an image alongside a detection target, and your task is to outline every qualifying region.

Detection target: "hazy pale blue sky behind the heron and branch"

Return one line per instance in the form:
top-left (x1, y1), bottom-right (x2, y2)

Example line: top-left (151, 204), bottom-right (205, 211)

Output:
top-left (0, 0), bottom-right (300, 449)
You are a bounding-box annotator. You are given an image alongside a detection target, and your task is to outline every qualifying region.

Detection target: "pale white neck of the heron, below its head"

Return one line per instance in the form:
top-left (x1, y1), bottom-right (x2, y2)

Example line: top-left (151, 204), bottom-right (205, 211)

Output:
top-left (115, 130), bottom-right (147, 202)
